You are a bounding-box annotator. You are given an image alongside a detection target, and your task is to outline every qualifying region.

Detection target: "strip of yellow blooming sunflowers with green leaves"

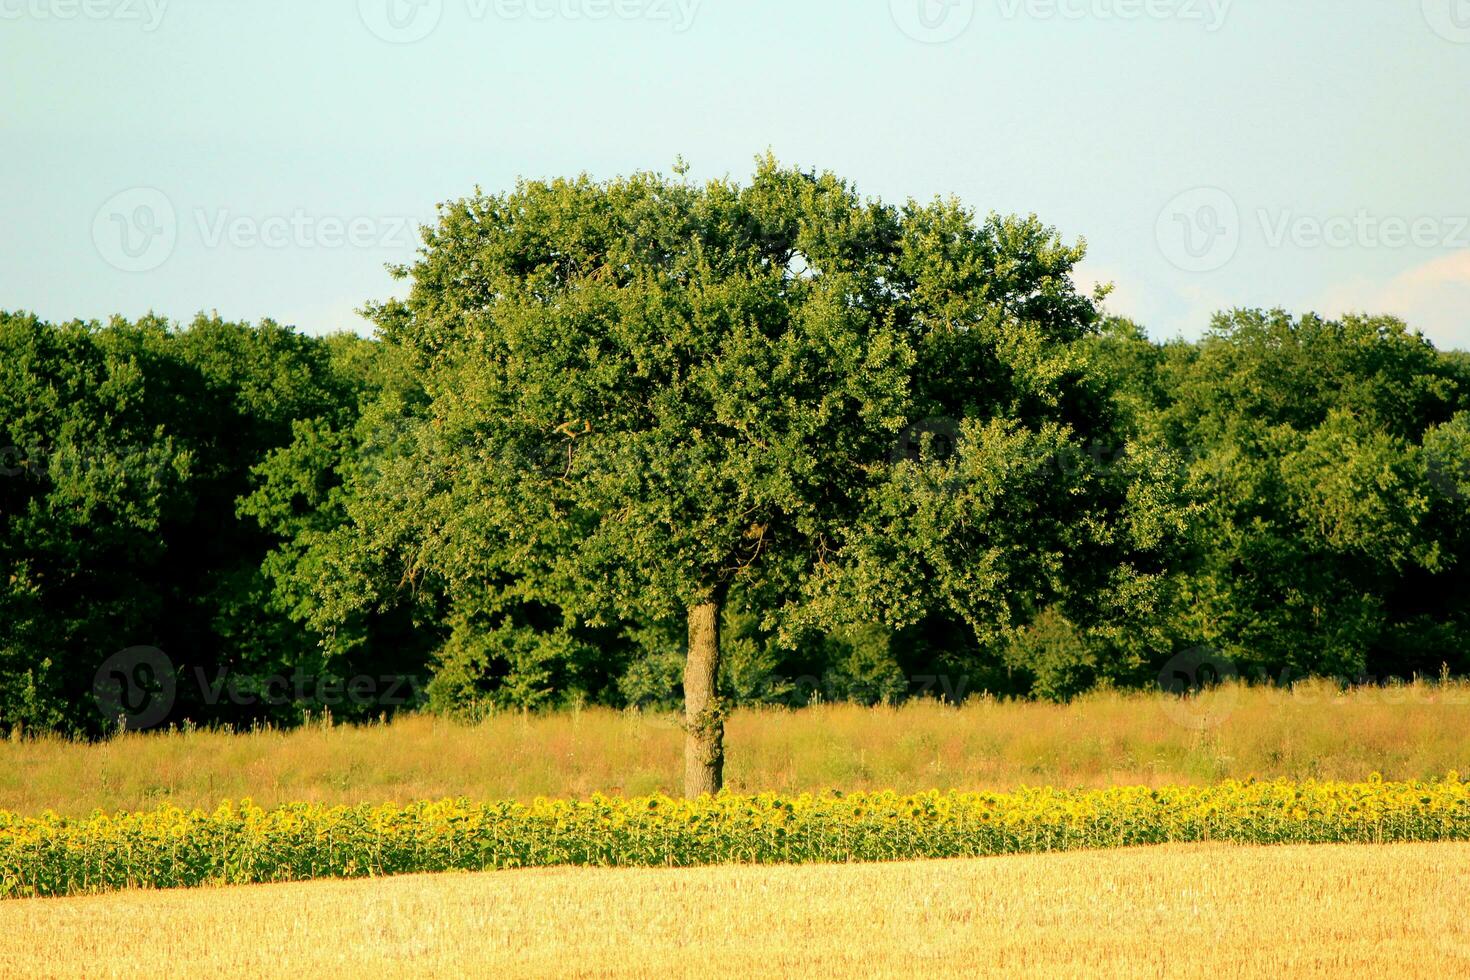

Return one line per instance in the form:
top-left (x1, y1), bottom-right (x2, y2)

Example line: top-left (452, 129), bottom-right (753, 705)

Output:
top-left (0, 773), bottom-right (1470, 898)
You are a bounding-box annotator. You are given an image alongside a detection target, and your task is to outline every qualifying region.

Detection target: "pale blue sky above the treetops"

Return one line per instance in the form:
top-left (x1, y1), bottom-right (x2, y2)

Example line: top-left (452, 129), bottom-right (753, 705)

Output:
top-left (0, 0), bottom-right (1470, 348)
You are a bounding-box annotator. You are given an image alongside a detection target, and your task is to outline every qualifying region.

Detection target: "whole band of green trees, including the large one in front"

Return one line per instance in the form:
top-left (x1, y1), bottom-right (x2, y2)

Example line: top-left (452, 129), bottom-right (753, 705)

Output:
top-left (0, 159), bottom-right (1470, 769)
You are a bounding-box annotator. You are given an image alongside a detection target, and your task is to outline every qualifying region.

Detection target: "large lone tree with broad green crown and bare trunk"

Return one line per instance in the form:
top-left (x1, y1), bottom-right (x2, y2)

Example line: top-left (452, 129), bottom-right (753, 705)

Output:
top-left (361, 157), bottom-right (1160, 795)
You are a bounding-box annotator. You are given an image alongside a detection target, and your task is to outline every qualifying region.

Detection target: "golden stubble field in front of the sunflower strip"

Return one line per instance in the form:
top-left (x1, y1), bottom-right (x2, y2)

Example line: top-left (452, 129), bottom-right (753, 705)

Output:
top-left (0, 845), bottom-right (1470, 979)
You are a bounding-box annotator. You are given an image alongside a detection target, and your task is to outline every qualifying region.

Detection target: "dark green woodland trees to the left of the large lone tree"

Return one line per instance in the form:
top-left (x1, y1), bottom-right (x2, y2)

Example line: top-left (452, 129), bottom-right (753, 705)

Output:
top-left (0, 313), bottom-right (402, 732)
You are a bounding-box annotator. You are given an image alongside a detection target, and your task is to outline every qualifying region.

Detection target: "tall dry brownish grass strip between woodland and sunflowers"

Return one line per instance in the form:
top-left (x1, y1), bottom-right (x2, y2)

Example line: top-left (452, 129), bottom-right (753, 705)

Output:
top-left (0, 685), bottom-right (1470, 814)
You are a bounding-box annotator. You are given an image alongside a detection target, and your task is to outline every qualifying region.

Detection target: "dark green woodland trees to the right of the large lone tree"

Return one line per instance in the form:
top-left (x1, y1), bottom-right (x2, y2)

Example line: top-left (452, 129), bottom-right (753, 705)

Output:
top-left (1100, 310), bottom-right (1470, 679)
